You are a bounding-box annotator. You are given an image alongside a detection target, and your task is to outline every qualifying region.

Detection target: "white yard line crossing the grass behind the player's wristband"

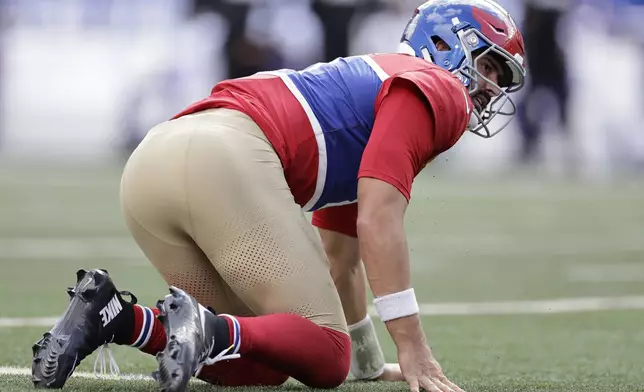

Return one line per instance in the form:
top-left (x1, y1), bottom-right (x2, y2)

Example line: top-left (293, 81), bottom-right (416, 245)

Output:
top-left (0, 296), bottom-right (644, 328)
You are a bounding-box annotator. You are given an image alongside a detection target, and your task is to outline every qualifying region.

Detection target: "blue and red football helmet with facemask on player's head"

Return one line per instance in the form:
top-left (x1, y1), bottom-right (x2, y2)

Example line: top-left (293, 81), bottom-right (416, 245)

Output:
top-left (399, 0), bottom-right (526, 138)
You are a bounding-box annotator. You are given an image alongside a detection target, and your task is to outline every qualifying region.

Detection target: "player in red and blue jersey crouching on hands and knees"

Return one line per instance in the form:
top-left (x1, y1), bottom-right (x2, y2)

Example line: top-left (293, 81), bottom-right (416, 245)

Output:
top-left (32, 0), bottom-right (525, 392)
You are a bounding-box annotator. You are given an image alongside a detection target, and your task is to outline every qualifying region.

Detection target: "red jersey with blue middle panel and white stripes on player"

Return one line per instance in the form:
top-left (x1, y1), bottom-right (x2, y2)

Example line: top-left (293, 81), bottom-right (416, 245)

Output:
top-left (174, 54), bottom-right (473, 236)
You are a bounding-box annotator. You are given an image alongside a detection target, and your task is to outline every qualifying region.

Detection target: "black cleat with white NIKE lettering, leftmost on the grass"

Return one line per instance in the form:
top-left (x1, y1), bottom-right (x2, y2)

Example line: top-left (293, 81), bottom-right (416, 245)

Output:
top-left (31, 269), bottom-right (137, 389)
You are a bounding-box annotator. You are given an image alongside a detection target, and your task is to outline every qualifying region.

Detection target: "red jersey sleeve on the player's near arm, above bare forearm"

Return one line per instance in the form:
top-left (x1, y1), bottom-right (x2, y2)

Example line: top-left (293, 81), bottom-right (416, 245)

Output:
top-left (358, 69), bottom-right (471, 200)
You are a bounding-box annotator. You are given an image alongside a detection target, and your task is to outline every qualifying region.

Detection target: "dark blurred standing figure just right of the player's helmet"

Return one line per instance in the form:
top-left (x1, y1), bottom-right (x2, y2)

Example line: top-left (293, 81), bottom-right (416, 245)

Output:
top-left (518, 0), bottom-right (571, 163)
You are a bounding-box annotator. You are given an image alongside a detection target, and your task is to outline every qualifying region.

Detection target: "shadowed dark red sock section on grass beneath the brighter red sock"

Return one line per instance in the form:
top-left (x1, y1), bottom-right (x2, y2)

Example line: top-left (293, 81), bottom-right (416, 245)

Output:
top-left (199, 357), bottom-right (288, 387)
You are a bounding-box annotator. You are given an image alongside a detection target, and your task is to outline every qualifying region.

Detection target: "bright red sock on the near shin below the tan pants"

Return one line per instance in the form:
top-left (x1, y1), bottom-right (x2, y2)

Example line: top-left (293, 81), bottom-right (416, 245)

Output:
top-left (221, 313), bottom-right (351, 388)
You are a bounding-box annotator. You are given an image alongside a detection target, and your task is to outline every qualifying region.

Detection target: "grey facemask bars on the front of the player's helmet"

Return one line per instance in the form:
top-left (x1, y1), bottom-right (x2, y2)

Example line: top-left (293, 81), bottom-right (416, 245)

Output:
top-left (452, 18), bottom-right (525, 138)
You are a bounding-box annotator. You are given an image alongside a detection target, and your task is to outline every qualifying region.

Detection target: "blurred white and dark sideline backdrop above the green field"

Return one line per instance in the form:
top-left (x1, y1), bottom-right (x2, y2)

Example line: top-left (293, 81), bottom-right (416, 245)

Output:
top-left (0, 0), bottom-right (644, 179)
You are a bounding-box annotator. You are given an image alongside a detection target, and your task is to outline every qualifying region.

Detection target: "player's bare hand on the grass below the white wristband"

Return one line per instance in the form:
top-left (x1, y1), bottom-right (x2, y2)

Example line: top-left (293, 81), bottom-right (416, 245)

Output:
top-left (398, 344), bottom-right (464, 392)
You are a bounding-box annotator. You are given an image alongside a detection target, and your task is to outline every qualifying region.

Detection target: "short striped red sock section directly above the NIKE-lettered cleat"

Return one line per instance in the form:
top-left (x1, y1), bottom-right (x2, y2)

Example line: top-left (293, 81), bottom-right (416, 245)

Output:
top-left (127, 305), bottom-right (166, 355)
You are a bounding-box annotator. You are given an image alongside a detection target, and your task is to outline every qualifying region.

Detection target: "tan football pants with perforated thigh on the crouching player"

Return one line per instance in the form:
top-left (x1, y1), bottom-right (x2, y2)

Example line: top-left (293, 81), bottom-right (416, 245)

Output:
top-left (121, 109), bottom-right (347, 333)
